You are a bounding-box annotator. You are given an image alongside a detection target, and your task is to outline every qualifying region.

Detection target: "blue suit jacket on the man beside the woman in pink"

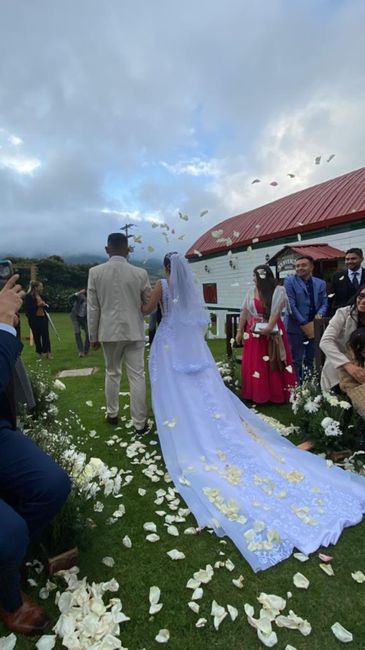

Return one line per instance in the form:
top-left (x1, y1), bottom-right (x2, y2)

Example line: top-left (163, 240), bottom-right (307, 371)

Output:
top-left (284, 274), bottom-right (328, 334)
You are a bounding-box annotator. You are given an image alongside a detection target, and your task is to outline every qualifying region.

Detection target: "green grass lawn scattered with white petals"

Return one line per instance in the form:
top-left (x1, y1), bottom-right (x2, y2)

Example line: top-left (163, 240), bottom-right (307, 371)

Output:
top-left (0, 314), bottom-right (365, 650)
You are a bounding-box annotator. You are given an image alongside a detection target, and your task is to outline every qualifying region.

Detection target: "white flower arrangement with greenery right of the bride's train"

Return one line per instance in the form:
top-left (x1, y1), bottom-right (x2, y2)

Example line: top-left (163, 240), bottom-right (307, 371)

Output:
top-left (290, 377), bottom-right (365, 453)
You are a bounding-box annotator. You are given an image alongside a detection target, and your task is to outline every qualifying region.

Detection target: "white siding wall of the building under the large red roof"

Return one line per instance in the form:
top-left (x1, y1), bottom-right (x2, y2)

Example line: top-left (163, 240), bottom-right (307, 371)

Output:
top-left (192, 227), bottom-right (365, 338)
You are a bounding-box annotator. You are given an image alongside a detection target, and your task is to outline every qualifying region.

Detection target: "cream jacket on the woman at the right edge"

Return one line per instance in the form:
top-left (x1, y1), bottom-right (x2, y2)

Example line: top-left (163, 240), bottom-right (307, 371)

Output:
top-left (319, 307), bottom-right (357, 391)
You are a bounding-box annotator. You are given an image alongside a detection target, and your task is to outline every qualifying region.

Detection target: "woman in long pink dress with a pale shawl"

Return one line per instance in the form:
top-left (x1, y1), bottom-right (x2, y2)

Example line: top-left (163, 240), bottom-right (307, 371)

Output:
top-left (236, 264), bottom-right (295, 404)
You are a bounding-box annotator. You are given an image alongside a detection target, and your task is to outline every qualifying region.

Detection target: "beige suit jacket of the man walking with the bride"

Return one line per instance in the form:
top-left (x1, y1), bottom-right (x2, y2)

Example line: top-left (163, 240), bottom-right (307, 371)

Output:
top-left (87, 256), bottom-right (151, 342)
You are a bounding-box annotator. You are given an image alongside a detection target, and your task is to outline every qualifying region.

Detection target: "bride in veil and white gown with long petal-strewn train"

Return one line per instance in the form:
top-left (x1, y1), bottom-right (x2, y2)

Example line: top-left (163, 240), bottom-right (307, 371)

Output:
top-left (142, 253), bottom-right (365, 571)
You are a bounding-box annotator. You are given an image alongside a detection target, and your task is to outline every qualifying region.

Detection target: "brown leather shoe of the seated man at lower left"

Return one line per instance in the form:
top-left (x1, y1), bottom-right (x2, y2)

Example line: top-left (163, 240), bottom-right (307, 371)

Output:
top-left (0, 592), bottom-right (50, 636)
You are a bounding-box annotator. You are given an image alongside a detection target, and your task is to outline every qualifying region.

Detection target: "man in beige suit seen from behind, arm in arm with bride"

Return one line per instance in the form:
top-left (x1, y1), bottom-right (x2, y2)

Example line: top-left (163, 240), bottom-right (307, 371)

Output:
top-left (87, 233), bottom-right (151, 433)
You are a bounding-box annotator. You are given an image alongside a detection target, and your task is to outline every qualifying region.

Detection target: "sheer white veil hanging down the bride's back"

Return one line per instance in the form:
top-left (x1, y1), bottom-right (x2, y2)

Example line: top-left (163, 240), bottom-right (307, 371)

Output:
top-left (168, 253), bottom-right (214, 373)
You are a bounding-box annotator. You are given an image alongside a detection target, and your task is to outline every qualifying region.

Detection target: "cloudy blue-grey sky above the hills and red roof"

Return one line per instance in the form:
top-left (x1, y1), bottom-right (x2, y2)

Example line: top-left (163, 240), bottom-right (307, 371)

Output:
top-left (0, 0), bottom-right (365, 259)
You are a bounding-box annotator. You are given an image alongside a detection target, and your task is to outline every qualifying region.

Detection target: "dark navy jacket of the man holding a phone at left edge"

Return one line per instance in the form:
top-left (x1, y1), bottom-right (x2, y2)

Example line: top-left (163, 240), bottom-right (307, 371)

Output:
top-left (0, 330), bottom-right (23, 429)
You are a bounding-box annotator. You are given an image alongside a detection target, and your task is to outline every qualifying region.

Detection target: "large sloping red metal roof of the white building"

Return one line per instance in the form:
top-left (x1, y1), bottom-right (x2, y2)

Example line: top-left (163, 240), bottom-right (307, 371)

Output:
top-left (186, 167), bottom-right (365, 258)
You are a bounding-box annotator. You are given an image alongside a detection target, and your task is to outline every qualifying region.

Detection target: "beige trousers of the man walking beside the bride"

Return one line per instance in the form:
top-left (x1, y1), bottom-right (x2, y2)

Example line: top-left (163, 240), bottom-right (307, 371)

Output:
top-left (102, 341), bottom-right (147, 429)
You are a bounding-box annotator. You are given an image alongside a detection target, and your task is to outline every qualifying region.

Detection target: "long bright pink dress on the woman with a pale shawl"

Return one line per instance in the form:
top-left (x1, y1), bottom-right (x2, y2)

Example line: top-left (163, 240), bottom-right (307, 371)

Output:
top-left (242, 298), bottom-right (295, 404)
